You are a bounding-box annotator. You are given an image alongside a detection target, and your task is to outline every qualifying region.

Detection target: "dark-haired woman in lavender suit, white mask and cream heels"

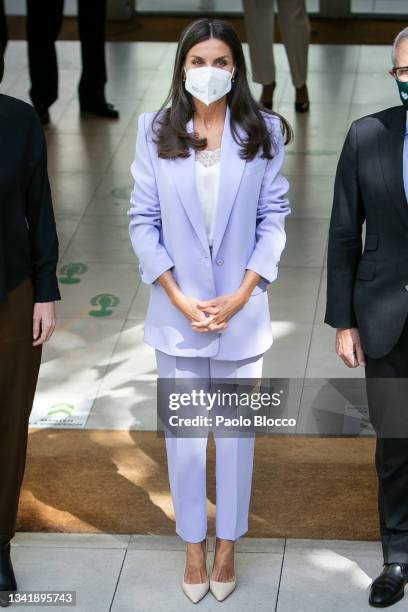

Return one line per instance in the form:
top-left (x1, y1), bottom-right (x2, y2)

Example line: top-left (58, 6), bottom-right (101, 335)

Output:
top-left (128, 19), bottom-right (291, 602)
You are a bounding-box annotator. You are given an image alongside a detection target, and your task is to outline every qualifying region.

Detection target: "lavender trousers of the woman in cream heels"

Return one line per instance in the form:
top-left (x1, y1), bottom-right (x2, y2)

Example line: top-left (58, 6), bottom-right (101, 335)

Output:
top-left (156, 349), bottom-right (263, 542)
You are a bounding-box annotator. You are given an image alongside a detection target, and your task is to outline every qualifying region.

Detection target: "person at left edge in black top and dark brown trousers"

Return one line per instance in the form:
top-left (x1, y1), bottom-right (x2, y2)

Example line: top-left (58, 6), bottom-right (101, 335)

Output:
top-left (0, 49), bottom-right (61, 605)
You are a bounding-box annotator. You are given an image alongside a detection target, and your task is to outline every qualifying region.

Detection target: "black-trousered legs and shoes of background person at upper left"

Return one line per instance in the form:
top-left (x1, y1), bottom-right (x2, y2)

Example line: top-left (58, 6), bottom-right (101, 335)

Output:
top-left (27, 0), bottom-right (119, 124)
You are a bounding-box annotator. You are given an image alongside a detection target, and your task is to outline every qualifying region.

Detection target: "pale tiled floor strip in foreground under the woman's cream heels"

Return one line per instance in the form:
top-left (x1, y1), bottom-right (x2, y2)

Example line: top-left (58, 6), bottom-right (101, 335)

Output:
top-left (7, 533), bottom-right (392, 612)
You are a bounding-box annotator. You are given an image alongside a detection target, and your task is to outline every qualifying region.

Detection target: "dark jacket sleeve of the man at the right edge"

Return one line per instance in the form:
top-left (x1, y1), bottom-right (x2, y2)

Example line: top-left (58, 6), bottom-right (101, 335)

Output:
top-left (324, 122), bottom-right (365, 328)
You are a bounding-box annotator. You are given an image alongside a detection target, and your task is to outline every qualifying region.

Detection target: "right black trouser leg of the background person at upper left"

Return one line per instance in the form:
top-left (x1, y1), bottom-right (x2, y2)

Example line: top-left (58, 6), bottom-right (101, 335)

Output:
top-left (78, 0), bottom-right (106, 104)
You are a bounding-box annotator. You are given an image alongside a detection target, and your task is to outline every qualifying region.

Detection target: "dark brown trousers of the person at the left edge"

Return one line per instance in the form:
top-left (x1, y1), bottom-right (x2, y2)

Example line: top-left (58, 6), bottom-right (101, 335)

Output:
top-left (0, 280), bottom-right (42, 541)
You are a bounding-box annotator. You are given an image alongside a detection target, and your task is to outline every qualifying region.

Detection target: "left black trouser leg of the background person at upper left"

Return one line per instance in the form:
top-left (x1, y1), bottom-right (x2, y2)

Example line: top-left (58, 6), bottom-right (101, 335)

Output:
top-left (27, 0), bottom-right (64, 108)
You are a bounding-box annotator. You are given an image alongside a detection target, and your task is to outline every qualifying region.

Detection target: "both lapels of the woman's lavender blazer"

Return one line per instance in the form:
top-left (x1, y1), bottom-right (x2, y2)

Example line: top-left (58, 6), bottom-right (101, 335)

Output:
top-left (169, 105), bottom-right (246, 258)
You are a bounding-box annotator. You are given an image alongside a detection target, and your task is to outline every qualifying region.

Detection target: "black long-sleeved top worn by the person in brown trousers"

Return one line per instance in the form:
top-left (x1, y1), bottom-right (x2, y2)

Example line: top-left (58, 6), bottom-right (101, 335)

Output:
top-left (0, 94), bottom-right (61, 302)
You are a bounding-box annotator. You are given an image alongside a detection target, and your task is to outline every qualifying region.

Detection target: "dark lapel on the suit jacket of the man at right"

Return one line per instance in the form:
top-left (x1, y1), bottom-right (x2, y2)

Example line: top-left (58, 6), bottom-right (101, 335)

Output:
top-left (380, 106), bottom-right (408, 231)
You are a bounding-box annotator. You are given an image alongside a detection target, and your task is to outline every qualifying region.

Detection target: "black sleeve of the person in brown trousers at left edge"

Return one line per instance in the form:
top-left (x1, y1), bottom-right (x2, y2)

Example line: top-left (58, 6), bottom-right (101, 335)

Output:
top-left (25, 110), bottom-right (61, 302)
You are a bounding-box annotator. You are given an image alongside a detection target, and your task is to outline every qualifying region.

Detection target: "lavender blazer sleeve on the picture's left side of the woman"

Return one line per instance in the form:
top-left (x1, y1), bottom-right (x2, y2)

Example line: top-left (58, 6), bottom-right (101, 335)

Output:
top-left (127, 113), bottom-right (174, 284)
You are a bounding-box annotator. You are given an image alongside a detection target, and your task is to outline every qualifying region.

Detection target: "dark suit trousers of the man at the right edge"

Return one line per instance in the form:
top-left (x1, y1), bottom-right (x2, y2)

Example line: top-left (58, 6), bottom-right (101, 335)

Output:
top-left (366, 325), bottom-right (408, 563)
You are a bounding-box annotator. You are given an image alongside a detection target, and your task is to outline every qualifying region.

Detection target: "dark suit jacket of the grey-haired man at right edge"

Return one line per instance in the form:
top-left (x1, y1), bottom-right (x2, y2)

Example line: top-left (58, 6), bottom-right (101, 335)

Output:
top-left (325, 106), bottom-right (408, 358)
